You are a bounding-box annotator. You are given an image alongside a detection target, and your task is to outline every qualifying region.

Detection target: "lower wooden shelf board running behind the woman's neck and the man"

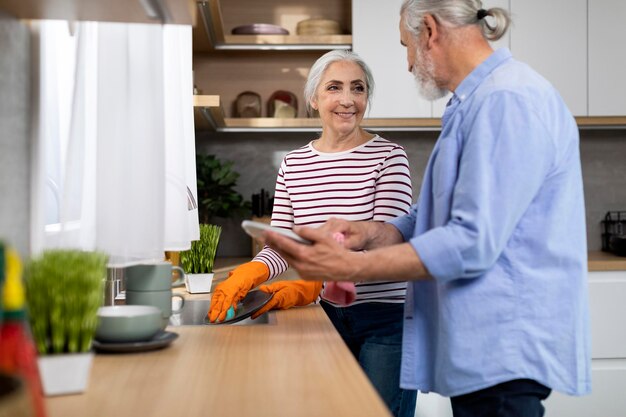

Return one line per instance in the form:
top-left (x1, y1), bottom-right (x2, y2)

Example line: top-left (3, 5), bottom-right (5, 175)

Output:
top-left (194, 95), bottom-right (626, 132)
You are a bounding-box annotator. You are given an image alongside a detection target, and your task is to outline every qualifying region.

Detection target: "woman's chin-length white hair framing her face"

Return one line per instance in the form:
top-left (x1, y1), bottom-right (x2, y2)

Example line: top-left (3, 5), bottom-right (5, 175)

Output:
top-left (304, 49), bottom-right (374, 112)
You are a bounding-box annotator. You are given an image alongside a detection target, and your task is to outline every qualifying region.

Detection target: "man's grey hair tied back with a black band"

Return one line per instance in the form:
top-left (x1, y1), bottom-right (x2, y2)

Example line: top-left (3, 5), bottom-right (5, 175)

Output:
top-left (400, 0), bottom-right (511, 41)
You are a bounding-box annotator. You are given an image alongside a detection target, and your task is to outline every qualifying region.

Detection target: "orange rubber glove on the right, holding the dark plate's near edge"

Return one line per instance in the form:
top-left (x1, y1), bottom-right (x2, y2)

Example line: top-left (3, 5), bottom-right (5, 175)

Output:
top-left (252, 280), bottom-right (322, 319)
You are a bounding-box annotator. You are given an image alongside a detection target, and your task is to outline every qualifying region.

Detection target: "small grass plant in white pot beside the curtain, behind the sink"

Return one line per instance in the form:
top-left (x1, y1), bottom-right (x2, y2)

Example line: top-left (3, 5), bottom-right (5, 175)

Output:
top-left (180, 224), bottom-right (222, 294)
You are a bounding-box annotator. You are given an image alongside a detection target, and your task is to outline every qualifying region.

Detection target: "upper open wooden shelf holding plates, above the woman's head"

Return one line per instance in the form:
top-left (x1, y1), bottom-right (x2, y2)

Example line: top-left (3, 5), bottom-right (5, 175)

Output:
top-left (194, 0), bottom-right (352, 52)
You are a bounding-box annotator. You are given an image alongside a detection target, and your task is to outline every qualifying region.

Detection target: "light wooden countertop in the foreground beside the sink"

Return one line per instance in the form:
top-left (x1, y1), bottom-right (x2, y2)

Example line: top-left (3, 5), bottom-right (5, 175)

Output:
top-left (46, 305), bottom-right (390, 417)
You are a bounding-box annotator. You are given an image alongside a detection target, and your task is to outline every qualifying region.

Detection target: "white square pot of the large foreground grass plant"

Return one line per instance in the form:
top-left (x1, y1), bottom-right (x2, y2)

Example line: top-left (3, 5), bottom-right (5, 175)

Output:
top-left (37, 352), bottom-right (94, 395)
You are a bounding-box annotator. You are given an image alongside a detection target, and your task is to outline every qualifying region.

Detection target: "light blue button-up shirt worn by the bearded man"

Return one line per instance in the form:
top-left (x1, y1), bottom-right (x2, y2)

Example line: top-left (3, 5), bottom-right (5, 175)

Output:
top-left (390, 49), bottom-right (591, 396)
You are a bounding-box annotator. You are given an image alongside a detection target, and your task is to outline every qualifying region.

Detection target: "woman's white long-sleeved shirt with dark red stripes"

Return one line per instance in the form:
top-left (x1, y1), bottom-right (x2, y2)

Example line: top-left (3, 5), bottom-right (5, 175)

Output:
top-left (253, 136), bottom-right (412, 304)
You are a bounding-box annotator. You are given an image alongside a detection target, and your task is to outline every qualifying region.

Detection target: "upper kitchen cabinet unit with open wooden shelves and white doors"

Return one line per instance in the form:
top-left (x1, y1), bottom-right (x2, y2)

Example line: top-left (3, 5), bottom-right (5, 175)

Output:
top-left (194, 0), bottom-right (626, 132)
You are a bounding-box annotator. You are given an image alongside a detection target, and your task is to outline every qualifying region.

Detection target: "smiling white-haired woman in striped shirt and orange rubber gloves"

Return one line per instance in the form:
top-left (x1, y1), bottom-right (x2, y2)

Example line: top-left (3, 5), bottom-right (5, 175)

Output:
top-left (209, 51), bottom-right (417, 417)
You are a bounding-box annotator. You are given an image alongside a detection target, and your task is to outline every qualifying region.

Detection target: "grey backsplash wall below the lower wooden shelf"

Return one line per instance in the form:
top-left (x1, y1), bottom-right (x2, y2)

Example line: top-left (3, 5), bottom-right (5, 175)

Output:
top-left (196, 130), bottom-right (626, 256)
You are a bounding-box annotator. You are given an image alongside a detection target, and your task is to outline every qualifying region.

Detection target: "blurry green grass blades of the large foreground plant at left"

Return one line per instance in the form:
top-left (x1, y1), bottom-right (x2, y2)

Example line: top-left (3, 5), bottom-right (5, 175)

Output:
top-left (25, 249), bottom-right (107, 355)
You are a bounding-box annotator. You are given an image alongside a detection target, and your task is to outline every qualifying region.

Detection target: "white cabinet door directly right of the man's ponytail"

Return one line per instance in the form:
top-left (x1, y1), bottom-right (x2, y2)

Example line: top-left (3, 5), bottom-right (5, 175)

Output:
top-left (511, 0), bottom-right (587, 116)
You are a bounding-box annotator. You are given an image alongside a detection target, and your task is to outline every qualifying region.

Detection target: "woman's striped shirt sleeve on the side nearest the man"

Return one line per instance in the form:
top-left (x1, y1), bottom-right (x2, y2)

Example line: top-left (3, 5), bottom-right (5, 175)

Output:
top-left (372, 146), bottom-right (413, 221)
